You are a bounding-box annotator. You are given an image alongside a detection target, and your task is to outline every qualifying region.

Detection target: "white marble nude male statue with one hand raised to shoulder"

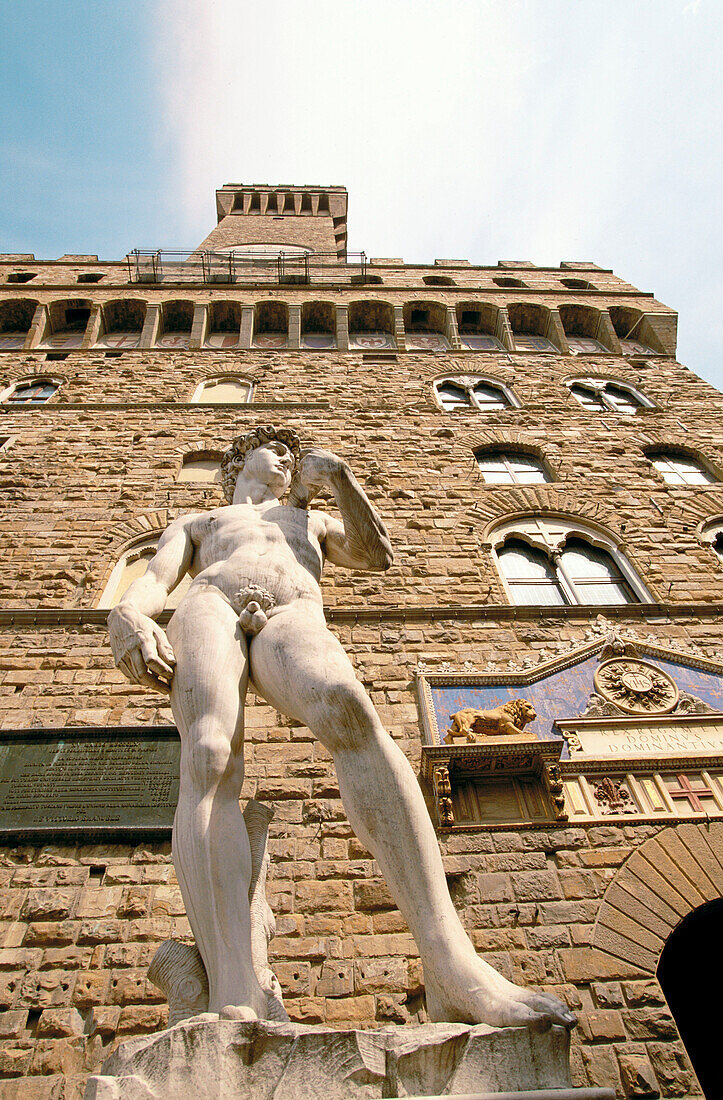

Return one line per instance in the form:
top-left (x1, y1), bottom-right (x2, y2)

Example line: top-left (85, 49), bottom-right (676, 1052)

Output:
top-left (108, 426), bottom-right (574, 1029)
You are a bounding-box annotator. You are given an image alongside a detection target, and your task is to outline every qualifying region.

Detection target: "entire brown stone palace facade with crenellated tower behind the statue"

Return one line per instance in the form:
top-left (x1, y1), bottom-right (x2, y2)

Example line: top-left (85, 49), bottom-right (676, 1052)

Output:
top-left (0, 184), bottom-right (723, 1100)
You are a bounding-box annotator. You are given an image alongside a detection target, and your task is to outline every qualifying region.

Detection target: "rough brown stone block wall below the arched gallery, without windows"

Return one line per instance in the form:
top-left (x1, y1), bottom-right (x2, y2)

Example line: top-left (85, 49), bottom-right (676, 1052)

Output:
top-left (0, 281), bottom-right (723, 1100)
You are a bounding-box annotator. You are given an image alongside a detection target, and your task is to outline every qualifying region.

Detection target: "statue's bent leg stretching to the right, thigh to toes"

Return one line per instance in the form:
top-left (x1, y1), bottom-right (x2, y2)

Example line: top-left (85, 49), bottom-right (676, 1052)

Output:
top-left (250, 604), bottom-right (574, 1027)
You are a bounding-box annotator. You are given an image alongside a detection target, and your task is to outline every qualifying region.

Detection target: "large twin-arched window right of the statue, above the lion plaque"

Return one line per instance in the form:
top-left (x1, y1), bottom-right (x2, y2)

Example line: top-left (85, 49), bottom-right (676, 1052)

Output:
top-left (494, 517), bottom-right (650, 606)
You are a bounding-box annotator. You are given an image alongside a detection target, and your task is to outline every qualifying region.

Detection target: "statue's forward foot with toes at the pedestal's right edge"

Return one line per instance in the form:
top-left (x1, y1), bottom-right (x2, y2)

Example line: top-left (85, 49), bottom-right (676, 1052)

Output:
top-left (425, 956), bottom-right (578, 1031)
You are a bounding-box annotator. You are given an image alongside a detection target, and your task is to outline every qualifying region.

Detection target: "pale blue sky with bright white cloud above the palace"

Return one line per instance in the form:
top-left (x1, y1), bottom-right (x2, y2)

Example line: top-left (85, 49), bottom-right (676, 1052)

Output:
top-left (0, 0), bottom-right (723, 386)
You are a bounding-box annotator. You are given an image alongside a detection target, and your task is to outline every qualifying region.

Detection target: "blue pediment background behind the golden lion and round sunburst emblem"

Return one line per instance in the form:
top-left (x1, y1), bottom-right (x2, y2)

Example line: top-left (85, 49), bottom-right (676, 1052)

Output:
top-left (430, 653), bottom-right (723, 745)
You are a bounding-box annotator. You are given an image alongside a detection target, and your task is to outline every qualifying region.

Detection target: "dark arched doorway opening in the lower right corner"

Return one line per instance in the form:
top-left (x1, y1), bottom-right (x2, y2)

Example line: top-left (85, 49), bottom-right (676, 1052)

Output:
top-left (658, 899), bottom-right (723, 1100)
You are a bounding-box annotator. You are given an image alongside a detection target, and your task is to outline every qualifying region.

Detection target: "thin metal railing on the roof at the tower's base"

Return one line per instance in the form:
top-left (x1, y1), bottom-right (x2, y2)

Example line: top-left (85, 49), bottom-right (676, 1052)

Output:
top-left (127, 249), bottom-right (368, 286)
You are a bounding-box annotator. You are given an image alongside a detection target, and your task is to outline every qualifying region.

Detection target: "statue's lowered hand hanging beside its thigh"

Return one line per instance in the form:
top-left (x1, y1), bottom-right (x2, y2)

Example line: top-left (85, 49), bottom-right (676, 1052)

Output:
top-left (108, 604), bottom-right (176, 695)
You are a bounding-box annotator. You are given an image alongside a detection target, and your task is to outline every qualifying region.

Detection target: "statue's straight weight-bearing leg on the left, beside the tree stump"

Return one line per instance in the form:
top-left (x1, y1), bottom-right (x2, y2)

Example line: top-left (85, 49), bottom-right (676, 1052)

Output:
top-left (168, 589), bottom-right (266, 1019)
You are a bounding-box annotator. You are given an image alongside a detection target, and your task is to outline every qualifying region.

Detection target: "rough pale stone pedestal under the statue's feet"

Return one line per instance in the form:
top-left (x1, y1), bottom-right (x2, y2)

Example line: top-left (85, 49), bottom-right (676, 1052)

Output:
top-left (86, 1014), bottom-right (614, 1100)
